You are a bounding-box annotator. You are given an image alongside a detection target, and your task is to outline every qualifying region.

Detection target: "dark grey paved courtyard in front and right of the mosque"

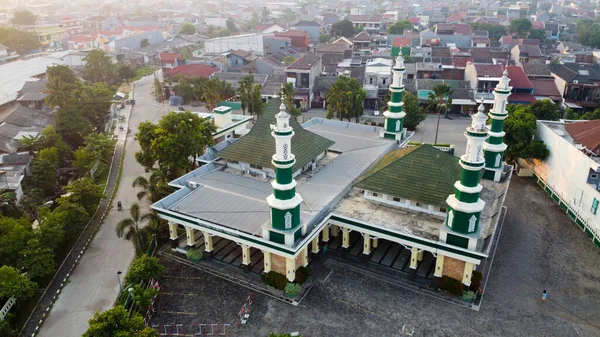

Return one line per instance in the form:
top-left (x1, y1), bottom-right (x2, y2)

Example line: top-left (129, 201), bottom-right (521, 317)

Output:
top-left (152, 177), bottom-right (600, 337)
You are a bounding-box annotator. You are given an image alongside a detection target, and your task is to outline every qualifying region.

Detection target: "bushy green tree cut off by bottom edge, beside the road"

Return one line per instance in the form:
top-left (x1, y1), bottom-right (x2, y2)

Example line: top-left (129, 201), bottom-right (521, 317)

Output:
top-left (82, 305), bottom-right (158, 337)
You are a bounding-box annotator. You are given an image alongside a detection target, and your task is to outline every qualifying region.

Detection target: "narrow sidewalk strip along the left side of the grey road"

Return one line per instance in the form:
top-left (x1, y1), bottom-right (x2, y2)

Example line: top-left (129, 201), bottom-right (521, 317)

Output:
top-left (20, 102), bottom-right (131, 337)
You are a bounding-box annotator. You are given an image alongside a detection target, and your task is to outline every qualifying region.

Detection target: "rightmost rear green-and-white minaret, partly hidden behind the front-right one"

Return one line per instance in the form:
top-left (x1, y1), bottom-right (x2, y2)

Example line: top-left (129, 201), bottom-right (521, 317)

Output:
top-left (483, 69), bottom-right (512, 181)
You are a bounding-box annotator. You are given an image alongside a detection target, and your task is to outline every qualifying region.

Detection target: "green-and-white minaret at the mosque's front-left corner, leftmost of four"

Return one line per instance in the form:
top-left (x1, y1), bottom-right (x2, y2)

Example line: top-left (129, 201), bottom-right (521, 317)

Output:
top-left (263, 103), bottom-right (302, 246)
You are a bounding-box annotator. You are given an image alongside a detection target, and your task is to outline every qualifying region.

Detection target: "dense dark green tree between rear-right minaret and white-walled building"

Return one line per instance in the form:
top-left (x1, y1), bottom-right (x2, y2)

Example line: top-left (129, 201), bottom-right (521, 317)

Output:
top-left (504, 106), bottom-right (549, 159)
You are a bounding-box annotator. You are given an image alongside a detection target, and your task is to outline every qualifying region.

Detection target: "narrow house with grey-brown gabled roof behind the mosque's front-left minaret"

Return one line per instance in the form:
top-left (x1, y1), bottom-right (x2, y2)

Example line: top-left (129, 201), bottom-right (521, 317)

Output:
top-left (285, 53), bottom-right (322, 104)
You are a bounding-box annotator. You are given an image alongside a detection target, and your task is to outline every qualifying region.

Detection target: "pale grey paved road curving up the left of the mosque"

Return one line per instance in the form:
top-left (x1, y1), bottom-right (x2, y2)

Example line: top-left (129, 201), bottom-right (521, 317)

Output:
top-left (38, 76), bottom-right (165, 337)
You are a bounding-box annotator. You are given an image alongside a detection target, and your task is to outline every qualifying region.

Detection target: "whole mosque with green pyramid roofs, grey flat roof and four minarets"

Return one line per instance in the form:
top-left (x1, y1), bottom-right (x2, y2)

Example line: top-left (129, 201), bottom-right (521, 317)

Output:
top-left (152, 56), bottom-right (511, 285)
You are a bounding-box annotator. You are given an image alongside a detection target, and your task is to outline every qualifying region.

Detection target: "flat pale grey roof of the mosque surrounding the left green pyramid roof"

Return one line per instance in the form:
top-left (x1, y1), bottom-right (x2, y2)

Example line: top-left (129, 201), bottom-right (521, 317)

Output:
top-left (152, 117), bottom-right (396, 237)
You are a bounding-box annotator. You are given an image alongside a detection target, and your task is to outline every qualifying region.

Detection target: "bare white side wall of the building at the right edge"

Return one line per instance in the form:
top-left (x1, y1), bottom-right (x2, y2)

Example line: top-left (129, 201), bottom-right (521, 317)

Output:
top-left (535, 121), bottom-right (600, 234)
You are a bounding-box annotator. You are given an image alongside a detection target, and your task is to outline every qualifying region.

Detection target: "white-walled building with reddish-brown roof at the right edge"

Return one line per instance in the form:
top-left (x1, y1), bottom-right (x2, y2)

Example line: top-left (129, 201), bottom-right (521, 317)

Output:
top-left (529, 120), bottom-right (600, 247)
